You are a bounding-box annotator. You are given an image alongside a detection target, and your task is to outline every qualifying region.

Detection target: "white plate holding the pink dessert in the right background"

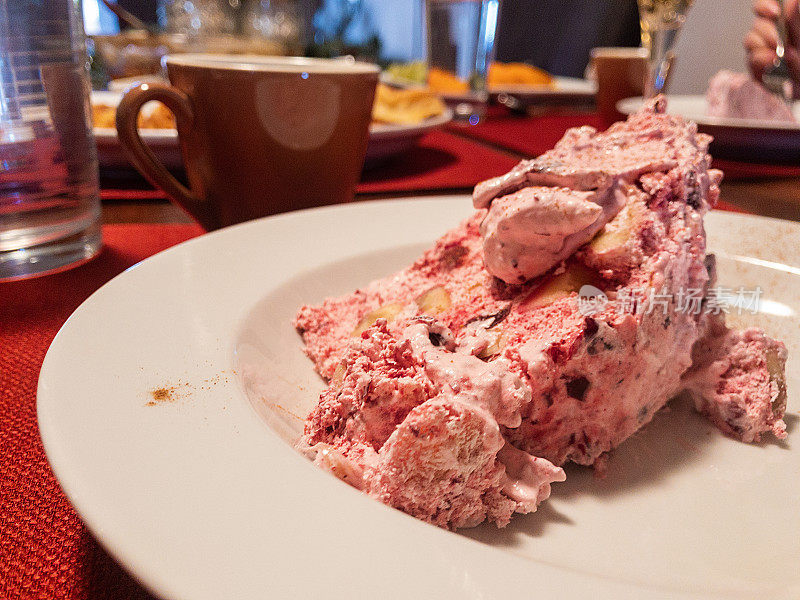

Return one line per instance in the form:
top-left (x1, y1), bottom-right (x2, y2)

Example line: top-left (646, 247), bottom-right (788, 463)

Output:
top-left (617, 96), bottom-right (800, 164)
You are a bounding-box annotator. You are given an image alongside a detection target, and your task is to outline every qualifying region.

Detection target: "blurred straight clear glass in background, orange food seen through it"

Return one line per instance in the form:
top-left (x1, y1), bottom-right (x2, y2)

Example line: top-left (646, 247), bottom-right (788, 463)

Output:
top-left (425, 0), bottom-right (500, 125)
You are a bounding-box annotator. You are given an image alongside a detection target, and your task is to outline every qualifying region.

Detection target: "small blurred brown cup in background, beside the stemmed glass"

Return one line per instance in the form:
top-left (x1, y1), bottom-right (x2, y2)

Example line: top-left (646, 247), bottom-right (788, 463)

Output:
top-left (591, 48), bottom-right (647, 125)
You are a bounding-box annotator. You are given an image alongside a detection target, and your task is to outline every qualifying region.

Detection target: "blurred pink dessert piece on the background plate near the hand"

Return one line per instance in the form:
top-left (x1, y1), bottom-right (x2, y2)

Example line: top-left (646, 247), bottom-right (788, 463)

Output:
top-left (706, 70), bottom-right (797, 123)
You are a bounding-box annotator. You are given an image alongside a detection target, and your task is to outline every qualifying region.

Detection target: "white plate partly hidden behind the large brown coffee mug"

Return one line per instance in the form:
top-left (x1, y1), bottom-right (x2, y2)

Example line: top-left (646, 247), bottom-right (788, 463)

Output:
top-left (92, 91), bottom-right (453, 169)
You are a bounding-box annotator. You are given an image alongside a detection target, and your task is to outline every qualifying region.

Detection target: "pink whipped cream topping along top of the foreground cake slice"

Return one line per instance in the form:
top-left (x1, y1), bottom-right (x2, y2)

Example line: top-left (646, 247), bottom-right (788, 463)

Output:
top-left (473, 99), bottom-right (710, 284)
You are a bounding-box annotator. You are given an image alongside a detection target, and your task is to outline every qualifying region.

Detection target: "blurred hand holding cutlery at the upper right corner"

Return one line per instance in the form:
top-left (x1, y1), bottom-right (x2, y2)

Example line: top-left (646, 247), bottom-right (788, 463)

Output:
top-left (744, 0), bottom-right (800, 96)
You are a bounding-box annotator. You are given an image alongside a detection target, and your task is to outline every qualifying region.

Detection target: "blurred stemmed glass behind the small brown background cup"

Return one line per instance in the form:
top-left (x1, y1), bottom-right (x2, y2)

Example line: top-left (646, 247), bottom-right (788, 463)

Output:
top-left (638, 0), bottom-right (694, 98)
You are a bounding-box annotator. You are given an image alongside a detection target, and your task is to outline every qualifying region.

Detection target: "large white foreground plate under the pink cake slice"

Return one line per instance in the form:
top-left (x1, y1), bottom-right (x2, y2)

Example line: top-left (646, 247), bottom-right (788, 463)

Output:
top-left (38, 196), bottom-right (800, 600)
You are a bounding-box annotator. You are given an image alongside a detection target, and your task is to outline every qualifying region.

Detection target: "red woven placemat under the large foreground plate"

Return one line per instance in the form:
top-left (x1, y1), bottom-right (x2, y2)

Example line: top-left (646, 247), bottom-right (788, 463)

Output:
top-left (0, 225), bottom-right (201, 600)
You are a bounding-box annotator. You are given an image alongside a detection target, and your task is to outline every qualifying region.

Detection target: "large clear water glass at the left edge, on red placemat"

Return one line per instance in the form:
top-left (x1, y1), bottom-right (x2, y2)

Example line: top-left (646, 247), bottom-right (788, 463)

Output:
top-left (0, 0), bottom-right (101, 280)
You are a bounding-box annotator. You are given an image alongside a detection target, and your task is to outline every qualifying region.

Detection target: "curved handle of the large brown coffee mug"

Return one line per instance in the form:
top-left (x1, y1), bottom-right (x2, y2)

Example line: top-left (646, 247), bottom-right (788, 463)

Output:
top-left (116, 83), bottom-right (214, 229)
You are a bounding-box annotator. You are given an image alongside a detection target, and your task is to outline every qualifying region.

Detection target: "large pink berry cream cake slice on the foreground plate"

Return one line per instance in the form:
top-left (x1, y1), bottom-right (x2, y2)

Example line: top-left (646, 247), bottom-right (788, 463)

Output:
top-left (295, 99), bottom-right (786, 528)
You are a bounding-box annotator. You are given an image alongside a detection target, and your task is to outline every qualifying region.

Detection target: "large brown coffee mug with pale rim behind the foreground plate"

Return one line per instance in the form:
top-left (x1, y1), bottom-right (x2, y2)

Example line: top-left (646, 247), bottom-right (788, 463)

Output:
top-left (117, 54), bottom-right (379, 230)
